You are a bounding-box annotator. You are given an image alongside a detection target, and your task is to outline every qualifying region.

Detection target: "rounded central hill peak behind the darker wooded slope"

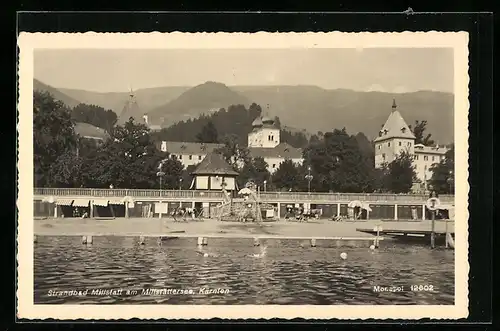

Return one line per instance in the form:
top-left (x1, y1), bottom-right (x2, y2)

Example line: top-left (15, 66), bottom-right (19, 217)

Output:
top-left (148, 82), bottom-right (251, 127)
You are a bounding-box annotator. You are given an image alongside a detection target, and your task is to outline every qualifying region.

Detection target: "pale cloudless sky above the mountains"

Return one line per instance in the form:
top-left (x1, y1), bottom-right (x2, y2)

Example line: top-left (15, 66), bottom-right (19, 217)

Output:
top-left (34, 48), bottom-right (454, 93)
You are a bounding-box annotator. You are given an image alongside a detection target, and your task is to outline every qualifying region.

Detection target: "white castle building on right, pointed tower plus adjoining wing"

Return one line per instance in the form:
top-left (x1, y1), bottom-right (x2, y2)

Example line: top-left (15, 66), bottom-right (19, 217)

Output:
top-left (374, 101), bottom-right (448, 191)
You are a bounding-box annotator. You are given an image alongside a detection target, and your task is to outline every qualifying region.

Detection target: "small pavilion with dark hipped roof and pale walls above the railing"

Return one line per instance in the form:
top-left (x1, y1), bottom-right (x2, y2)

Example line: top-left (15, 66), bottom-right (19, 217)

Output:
top-left (191, 152), bottom-right (238, 191)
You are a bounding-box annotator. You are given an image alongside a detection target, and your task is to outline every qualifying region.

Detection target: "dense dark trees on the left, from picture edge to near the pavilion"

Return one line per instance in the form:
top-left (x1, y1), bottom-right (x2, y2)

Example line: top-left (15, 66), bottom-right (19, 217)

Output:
top-left (33, 92), bottom-right (183, 188)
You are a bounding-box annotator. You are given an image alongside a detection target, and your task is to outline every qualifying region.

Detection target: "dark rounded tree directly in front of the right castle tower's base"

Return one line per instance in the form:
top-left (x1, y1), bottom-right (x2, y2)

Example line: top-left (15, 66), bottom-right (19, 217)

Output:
top-left (384, 152), bottom-right (416, 193)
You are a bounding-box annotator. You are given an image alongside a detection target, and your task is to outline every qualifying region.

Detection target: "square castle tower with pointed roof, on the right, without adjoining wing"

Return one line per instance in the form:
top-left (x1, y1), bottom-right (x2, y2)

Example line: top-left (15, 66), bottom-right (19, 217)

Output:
top-left (375, 99), bottom-right (415, 168)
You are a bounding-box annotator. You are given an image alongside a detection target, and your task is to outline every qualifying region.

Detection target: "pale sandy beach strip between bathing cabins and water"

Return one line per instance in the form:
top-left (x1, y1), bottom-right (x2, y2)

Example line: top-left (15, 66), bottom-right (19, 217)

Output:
top-left (34, 218), bottom-right (454, 238)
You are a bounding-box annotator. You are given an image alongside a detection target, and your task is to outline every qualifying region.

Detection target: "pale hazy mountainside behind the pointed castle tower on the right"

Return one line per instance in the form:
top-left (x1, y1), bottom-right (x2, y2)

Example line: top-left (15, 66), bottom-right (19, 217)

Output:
top-left (233, 86), bottom-right (454, 143)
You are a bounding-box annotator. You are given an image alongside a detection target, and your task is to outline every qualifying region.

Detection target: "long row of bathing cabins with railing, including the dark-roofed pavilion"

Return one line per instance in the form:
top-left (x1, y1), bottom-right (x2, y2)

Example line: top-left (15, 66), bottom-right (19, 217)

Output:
top-left (34, 153), bottom-right (454, 220)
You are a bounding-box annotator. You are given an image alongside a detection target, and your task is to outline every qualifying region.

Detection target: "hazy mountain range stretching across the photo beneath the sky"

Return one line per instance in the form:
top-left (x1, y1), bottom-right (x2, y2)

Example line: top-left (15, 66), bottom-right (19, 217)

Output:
top-left (33, 82), bottom-right (454, 143)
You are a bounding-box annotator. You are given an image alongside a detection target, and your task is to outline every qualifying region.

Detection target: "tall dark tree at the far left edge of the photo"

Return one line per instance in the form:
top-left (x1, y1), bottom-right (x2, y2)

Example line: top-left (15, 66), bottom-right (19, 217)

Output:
top-left (33, 91), bottom-right (77, 186)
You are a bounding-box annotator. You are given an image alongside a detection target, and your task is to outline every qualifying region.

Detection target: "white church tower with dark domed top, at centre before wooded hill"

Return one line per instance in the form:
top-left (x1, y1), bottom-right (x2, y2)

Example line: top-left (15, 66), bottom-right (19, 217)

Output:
top-left (248, 106), bottom-right (280, 148)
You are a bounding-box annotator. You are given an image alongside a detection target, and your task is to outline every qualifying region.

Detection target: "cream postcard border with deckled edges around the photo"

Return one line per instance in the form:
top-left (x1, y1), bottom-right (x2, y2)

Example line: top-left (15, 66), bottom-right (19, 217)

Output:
top-left (17, 31), bottom-right (469, 320)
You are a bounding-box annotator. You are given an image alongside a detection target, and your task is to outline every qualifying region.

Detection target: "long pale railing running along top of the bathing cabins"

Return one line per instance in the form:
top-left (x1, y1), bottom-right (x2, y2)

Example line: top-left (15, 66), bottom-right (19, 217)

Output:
top-left (34, 188), bottom-right (455, 203)
